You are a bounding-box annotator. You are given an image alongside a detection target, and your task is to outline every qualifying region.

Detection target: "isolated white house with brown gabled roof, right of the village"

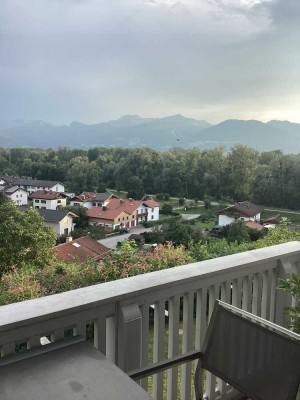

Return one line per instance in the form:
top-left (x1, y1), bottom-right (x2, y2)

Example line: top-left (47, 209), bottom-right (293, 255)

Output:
top-left (218, 201), bottom-right (262, 226)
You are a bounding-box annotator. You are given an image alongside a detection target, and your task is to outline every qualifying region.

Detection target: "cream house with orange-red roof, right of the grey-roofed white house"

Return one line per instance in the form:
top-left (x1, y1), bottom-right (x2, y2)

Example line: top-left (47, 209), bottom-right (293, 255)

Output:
top-left (87, 206), bottom-right (135, 230)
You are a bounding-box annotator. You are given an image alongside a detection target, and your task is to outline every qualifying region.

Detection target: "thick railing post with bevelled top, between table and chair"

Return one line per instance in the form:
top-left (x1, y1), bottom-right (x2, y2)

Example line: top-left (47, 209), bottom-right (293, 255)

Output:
top-left (117, 303), bottom-right (142, 372)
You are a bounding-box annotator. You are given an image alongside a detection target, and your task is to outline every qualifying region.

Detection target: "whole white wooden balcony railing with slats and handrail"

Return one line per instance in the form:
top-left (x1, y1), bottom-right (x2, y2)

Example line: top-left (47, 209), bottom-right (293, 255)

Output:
top-left (0, 242), bottom-right (300, 400)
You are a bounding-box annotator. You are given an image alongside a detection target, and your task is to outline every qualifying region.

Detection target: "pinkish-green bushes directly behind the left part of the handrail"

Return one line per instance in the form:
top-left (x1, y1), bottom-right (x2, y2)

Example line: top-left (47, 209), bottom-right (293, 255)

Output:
top-left (0, 241), bottom-right (193, 305)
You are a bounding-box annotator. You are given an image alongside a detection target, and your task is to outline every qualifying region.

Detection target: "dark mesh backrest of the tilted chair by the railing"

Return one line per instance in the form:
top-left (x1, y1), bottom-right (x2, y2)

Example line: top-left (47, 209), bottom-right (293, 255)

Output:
top-left (201, 300), bottom-right (300, 400)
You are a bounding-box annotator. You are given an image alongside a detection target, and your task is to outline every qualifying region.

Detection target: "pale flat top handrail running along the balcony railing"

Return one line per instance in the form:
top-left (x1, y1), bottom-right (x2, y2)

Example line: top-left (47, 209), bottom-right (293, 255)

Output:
top-left (0, 242), bottom-right (300, 332)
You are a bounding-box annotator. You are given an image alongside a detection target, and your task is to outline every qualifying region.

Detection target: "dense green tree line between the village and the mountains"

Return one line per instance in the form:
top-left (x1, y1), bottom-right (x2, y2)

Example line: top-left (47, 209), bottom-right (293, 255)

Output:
top-left (0, 145), bottom-right (300, 209)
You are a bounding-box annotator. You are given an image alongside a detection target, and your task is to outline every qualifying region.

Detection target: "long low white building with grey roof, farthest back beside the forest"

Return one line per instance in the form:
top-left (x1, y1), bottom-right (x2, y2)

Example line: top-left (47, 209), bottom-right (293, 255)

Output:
top-left (0, 175), bottom-right (65, 194)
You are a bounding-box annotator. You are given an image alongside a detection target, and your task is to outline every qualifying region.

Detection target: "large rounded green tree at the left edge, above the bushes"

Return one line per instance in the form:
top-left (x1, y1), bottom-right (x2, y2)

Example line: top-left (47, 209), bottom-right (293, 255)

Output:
top-left (0, 201), bottom-right (55, 274)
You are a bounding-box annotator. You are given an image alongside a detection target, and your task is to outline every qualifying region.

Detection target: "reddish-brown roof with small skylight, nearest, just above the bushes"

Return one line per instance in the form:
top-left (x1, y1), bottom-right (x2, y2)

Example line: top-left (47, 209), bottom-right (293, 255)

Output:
top-left (54, 236), bottom-right (110, 262)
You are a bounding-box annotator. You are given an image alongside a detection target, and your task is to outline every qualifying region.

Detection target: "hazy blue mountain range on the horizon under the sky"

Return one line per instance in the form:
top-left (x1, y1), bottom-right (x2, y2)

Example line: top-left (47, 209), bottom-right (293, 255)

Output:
top-left (0, 115), bottom-right (300, 153)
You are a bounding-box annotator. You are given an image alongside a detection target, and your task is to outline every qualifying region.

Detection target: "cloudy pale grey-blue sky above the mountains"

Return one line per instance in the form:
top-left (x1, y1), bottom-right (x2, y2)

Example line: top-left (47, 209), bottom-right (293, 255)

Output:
top-left (0, 0), bottom-right (300, 124)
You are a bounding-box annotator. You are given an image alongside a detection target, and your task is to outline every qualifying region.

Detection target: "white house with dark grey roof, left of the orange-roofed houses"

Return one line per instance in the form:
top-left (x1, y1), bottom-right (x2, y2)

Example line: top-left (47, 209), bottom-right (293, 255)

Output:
top-left (37, 209), bottom-right (77, 236)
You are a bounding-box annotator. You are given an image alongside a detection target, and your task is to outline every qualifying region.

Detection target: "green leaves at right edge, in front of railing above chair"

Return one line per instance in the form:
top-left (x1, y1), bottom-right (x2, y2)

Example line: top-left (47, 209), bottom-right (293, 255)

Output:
top-left (278, 272), bottom-right (300, 334)
